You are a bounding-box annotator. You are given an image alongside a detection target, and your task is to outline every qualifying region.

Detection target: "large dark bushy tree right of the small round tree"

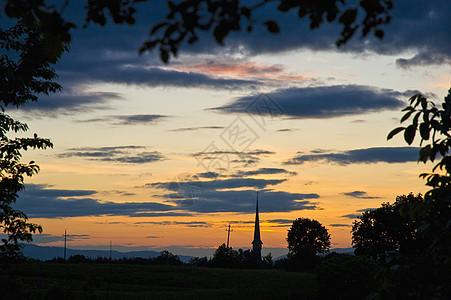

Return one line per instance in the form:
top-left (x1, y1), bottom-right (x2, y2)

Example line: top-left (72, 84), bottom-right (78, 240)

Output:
top-left (351, 194), bottom-right (424, 262)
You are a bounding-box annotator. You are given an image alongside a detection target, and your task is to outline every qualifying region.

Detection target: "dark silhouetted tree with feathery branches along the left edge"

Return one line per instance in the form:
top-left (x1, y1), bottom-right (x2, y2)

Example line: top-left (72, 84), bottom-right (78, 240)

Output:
top-left (0, 16), bottom-right (67, 260)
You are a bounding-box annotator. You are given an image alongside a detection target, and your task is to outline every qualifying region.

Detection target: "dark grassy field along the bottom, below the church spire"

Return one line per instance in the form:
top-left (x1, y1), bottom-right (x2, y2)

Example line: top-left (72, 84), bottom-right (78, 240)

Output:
top-left (0, 262), bottom-right (316, 300)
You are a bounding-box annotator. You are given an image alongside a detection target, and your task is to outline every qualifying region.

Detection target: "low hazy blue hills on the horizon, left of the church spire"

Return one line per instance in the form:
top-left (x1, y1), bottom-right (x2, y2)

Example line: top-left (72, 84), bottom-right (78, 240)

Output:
top-left (22, 244), bottom-right (192, 262)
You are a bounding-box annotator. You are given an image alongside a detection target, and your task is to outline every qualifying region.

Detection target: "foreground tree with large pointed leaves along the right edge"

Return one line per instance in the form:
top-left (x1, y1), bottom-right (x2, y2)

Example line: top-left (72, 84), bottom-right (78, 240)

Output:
top-left (382, 89), bottom-right (451, 299)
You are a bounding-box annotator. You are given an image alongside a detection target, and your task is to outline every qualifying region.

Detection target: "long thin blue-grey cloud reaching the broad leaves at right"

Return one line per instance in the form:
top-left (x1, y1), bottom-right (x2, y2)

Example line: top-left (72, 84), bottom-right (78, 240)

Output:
top-left (284, 147), bottom-right (419, 165)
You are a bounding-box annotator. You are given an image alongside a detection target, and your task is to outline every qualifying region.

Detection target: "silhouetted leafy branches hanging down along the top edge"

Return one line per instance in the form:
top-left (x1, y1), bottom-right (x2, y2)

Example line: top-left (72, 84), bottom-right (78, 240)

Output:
top-left (0, 0), bottom-right (393, 62)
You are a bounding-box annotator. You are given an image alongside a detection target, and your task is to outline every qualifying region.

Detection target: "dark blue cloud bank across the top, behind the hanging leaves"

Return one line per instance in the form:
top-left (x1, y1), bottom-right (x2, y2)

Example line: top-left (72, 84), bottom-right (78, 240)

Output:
top-left (43, 0), bottom-right (451, 98)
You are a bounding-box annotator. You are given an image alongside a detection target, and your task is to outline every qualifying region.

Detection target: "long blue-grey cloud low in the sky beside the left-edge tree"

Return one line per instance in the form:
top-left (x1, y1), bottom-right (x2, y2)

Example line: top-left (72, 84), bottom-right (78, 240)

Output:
top-left (14, 184), bottom-right (177, 218)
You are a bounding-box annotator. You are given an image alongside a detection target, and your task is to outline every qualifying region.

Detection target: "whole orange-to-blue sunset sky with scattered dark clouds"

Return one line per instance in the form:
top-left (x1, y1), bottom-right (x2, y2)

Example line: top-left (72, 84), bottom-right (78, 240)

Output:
top-left (6, 0), bottom-right (451, 256)
